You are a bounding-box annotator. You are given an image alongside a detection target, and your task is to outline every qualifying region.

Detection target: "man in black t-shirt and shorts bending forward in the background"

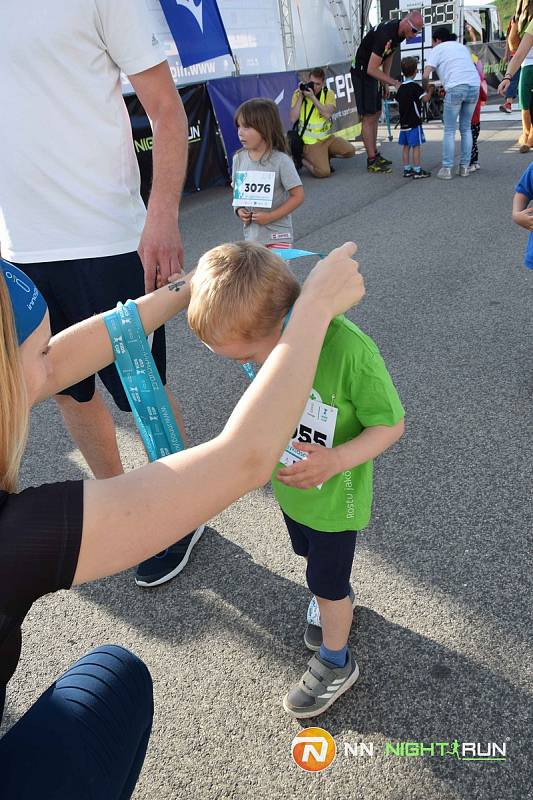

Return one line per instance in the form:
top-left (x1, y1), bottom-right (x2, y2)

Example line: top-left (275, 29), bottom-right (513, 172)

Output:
top-left (351, 11), bottom-right (424, 172)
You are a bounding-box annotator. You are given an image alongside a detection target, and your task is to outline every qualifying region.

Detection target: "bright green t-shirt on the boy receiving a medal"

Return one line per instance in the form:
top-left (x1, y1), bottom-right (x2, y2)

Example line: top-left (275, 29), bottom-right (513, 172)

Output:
top-left (272, 316), bottom-right (405, 531)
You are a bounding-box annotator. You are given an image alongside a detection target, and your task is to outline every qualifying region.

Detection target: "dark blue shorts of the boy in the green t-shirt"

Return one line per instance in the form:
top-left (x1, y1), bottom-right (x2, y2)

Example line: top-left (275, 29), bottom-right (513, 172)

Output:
top-left (283, 514), bottom-right (357, 600)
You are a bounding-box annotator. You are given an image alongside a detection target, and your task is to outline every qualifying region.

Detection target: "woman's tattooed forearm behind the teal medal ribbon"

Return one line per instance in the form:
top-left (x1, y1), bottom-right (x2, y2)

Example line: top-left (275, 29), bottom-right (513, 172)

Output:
top-left (37, 272), bottom-right (192, 402)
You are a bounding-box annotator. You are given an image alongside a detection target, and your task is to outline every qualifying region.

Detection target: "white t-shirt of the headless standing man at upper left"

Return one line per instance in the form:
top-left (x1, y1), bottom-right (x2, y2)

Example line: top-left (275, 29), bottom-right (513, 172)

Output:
top-left (0, 0), bottom-right (165, 263)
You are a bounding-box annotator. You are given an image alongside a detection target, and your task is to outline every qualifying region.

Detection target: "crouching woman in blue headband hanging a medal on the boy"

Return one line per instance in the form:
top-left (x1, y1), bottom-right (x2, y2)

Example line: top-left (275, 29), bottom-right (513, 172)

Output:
top-left (0, 247), bottom-right (364, 800)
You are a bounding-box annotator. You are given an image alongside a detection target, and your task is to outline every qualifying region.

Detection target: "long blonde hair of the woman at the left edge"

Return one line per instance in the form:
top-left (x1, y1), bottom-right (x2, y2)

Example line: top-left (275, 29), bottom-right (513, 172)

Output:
top-left (0, 276), bottom-right (29, 492)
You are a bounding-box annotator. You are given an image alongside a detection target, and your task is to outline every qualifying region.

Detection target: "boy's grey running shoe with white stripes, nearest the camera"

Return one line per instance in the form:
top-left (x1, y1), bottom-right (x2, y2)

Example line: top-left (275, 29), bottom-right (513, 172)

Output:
top-left (283, 651), bottom-right (359, 719)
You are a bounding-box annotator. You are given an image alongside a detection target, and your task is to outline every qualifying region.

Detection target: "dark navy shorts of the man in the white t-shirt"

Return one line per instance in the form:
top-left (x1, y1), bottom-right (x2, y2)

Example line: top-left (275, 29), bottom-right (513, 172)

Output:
top-left (17, 253), bottom-right (167, 411)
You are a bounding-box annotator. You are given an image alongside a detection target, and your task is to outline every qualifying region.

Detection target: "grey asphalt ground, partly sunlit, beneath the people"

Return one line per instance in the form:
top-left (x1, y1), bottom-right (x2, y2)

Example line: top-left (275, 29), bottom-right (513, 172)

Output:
top-left (4, 113), bottom-right (533, 800)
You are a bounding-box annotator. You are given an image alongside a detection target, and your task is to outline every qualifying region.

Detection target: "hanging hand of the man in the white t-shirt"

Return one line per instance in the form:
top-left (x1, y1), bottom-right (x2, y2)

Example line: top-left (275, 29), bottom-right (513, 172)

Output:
top-left (137, 214), bottom-right (184, 294)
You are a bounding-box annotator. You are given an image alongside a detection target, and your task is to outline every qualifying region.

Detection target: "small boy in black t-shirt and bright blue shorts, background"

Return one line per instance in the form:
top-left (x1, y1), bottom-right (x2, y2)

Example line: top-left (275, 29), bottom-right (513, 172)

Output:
top-left (396, 57), bottom-right (432, 180)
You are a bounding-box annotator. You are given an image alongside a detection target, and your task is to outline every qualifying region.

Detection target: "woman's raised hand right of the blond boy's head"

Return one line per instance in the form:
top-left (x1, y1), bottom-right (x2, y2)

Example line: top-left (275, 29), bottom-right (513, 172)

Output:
top-left (301, 242), bottom-right (365, 318)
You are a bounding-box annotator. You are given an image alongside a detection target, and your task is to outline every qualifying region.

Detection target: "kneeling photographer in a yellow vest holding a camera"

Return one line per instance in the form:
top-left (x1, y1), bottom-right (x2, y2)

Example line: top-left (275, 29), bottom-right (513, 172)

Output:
top-left (289, 68), bottom-right (355, 178)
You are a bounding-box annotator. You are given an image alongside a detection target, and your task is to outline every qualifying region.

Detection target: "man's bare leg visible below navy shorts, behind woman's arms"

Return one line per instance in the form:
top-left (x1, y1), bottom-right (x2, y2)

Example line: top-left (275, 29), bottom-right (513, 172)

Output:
top-left (55, 390), bottom-right (124, 478)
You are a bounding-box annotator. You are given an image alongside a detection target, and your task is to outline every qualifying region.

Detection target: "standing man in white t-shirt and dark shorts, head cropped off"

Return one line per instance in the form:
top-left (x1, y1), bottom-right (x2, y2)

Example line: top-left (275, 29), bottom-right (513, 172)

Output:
top-left (0, 0), bottom-right (204, 585)
